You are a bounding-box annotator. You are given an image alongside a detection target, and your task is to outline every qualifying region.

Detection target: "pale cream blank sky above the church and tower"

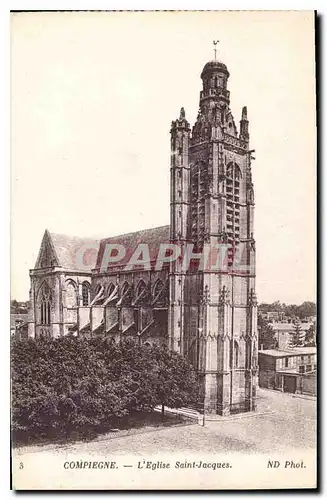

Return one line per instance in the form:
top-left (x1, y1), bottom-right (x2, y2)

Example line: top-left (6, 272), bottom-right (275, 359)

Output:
top-left (11, 11), bottom-right (316, 303)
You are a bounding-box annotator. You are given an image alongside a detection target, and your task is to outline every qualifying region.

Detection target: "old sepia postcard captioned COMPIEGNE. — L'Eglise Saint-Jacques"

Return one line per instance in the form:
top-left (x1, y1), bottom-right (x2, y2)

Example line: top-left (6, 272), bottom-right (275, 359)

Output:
top-left (10, 11), bottom-right (317, 491)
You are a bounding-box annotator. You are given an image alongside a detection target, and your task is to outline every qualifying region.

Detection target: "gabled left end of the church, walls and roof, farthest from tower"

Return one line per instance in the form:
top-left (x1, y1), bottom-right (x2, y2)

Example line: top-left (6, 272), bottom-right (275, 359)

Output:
top-left (28, 230), bottom-right (99, 337)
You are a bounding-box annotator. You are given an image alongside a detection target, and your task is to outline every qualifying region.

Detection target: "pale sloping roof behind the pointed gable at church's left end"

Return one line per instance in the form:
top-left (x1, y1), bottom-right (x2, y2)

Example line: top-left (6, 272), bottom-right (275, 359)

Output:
top-left (49, 232), bottom-right (100, 271)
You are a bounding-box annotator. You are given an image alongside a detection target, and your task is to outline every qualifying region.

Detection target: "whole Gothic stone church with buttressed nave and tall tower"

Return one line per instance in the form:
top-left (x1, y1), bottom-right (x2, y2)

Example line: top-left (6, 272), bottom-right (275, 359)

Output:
top-left (29, 56), bottom-right (258, 415)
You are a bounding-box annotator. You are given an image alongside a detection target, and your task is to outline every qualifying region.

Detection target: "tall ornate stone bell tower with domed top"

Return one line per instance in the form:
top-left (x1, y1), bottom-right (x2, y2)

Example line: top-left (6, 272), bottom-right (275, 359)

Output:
top-left (171, 52), bottom-right (257, 415)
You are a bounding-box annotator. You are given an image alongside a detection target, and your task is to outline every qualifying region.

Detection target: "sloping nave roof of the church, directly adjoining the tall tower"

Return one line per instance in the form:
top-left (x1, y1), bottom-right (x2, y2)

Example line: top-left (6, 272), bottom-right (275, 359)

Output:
top-left (96, 226), bottom-right (170, 270)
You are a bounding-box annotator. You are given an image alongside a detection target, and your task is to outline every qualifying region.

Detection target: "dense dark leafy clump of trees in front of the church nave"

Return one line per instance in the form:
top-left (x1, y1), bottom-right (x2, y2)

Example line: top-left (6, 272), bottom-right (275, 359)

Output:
top-left (11, 336), bottom-right (198, 440)
